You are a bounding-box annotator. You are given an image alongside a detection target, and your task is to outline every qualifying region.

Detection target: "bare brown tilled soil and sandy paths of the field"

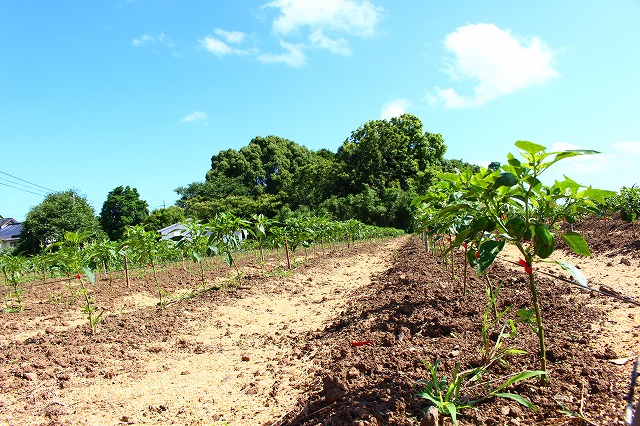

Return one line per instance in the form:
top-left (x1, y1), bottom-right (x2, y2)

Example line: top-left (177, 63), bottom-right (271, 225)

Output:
top-left (0, 219), bottom-right (640, 425)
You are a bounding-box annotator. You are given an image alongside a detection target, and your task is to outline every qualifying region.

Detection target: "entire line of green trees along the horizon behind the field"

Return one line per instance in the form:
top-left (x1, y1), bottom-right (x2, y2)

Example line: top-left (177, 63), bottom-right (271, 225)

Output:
top-left (10, 114), bottom-right (471, 254)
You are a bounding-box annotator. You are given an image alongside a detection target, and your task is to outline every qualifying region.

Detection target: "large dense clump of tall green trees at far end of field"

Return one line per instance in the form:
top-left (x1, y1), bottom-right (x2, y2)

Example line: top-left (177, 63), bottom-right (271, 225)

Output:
top-left (176, 114), bottom-right (466, 229)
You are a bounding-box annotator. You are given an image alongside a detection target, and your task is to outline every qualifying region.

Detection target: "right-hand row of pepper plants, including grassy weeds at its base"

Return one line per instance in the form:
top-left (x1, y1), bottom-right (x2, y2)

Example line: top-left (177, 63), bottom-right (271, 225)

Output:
top-left (413, 141), bottom-right (640, 423)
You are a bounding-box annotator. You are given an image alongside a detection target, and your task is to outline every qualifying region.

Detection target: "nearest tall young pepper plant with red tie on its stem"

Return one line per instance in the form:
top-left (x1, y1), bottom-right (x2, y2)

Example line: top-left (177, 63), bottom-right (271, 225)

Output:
top-left (441, 141), bottom-right (610, 383)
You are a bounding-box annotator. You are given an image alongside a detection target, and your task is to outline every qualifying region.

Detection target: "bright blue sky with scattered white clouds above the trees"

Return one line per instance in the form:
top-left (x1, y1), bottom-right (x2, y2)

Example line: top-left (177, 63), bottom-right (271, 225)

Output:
top-left (0, 0), bottom-right (640, 220)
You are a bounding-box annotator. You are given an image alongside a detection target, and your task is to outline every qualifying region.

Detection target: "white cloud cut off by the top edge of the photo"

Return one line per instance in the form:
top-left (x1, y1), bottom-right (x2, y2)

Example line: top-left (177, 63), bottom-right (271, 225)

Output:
top-left (264, 0), bottom-right (382, 36)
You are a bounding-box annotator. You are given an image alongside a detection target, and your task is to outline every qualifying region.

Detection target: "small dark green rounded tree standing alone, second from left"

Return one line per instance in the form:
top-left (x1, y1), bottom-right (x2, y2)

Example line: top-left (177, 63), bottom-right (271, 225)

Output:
top-left (100, 185), bottom-right (149, 241)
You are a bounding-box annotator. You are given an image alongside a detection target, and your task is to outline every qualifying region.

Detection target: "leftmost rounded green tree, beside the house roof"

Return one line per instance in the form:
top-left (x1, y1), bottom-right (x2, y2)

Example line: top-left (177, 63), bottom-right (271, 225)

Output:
top-left (16, 189), bottom-right (103, 254)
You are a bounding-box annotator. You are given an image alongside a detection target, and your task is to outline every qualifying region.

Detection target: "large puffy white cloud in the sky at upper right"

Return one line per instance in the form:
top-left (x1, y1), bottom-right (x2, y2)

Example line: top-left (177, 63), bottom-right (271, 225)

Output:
top-left (430, 23), bottom-right (559, 108)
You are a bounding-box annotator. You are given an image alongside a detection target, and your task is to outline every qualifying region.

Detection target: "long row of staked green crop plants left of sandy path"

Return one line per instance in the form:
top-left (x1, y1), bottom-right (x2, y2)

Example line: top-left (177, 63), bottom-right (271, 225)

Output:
top-left (0, 214), bottom-right (402, 332)
